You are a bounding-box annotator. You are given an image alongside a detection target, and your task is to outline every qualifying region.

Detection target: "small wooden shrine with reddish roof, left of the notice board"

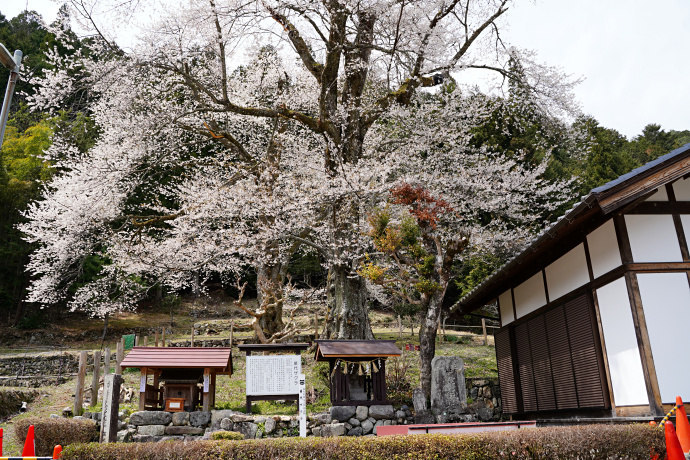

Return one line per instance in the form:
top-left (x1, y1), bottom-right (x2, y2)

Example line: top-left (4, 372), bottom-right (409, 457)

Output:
top-left (122, 347), bottom-right (233, 412)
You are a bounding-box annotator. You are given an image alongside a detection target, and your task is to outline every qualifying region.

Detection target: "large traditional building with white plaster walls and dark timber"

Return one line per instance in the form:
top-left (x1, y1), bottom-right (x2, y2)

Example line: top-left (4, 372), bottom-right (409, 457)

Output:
top-left (456, 144), bottom-right (690, 418)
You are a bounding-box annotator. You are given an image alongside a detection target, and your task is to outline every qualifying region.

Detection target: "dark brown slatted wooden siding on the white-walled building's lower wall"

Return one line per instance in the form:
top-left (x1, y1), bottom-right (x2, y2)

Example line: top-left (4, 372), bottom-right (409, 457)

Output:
top-left (496, 295), bottom-right (609, 413)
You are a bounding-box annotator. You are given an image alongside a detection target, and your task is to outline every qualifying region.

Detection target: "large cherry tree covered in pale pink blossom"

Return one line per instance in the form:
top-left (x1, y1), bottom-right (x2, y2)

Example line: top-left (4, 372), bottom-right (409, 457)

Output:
top-left (23, 0), bottom-right (572, 338)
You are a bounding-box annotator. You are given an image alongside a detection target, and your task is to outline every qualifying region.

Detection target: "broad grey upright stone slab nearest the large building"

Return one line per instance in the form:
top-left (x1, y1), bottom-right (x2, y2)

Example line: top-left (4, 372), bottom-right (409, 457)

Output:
top-left (428, 356), bottom-right (467, 412)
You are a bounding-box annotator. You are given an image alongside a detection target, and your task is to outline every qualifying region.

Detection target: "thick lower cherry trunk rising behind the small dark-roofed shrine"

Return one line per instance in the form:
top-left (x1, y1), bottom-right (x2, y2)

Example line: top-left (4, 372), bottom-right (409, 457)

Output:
top-left (327, 265), bottom-right (374, 340)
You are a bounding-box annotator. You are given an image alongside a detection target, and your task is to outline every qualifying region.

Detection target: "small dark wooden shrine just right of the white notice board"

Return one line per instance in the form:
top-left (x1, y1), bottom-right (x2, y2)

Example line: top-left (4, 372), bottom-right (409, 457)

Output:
top-left (315, 340), bottom-right (402, 406)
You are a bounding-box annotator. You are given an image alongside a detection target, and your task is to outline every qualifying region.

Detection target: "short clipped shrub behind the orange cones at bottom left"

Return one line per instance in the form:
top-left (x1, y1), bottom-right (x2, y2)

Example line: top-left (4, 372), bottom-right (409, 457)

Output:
top-left (14, 417), bottom-right (98, 456)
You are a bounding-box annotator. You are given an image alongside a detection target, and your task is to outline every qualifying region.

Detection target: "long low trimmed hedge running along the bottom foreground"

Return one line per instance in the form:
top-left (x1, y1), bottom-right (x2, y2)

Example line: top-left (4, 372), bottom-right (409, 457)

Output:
top-left (62, 425), bottom-right (666, 460)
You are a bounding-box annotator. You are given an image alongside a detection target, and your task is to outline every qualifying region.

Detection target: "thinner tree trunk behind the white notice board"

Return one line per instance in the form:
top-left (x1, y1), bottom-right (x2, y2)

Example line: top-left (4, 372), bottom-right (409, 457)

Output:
top-left (256, 263), bottom-right (284, 337)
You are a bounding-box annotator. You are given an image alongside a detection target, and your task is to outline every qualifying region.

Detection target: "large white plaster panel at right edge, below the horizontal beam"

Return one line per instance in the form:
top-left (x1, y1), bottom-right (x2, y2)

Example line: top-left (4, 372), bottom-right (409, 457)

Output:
top-left (637, 273), bottom-right (690, 404)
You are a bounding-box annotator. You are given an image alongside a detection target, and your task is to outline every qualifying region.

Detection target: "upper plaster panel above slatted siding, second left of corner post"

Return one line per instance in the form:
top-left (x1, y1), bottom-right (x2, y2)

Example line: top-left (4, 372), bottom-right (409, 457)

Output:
top-left (546, 244), bottom-right (589, 301)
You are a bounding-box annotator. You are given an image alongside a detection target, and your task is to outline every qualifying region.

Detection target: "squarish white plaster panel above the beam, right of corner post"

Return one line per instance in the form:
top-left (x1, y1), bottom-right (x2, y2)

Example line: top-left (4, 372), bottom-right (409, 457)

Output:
top-left (625, 214), bottom-right (683, 262)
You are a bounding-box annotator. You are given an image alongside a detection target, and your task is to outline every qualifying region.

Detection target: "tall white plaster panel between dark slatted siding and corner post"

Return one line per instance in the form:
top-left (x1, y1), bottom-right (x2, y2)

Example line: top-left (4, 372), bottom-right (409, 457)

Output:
top-left (597, 278), bottom-right (649, 406)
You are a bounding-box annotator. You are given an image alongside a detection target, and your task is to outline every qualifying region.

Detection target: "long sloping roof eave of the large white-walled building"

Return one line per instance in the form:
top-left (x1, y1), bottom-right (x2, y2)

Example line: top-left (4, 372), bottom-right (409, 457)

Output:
top-left (451, 143), bottom-right (690, 314)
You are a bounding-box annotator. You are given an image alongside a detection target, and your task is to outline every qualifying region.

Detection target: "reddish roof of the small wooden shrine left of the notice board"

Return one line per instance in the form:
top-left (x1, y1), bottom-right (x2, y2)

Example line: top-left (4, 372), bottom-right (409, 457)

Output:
top-left (122, 347), bottom-right (232, 373)
